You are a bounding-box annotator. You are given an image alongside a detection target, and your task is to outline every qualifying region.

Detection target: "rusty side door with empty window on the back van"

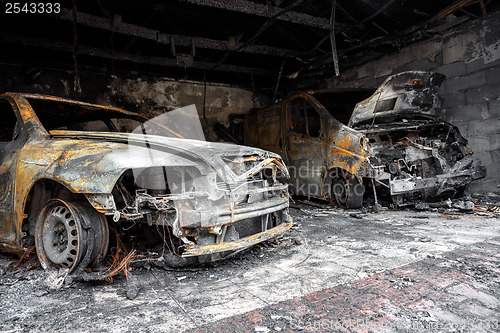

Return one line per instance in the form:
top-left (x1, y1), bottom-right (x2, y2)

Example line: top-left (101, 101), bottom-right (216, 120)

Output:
top-left (286, 95), bottom-right (325, 197)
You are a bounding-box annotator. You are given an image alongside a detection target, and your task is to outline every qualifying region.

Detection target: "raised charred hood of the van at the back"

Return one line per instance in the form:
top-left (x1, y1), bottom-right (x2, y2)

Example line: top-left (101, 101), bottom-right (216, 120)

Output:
top-left (349, 71), bottom-right (445, 128)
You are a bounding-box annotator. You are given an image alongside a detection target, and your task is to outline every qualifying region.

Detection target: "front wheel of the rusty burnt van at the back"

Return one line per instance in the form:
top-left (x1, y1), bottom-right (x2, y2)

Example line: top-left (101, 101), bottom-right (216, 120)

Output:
top-left (332, 175), bottom-right (365, 208)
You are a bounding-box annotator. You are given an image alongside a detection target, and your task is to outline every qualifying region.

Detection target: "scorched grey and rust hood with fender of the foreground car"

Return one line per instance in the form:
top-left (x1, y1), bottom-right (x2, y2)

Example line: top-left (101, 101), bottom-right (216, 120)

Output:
top-left (32, 130), bottom-right (286, 193)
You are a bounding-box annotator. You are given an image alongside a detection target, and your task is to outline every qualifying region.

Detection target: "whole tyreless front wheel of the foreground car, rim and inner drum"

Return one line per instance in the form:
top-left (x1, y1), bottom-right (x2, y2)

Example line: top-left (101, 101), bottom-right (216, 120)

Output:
top-left (35, 199), bottom-right (109, 272)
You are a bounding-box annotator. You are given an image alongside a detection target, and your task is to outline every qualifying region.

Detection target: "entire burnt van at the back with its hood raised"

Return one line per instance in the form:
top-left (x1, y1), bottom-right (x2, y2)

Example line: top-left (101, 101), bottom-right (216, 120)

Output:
top-left (245, 71), bottom-right (485, 208)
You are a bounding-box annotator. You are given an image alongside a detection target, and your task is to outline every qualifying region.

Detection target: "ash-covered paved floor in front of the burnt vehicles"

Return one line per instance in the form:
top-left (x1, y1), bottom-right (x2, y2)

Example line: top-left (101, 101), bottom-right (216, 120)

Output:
top-left (0, 204), bottom-right (500, 332)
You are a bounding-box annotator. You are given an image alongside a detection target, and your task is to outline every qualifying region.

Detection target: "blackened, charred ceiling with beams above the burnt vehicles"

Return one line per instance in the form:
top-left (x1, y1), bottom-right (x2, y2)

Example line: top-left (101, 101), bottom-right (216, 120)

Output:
top-left (0, 0), bottom-right (499, 89)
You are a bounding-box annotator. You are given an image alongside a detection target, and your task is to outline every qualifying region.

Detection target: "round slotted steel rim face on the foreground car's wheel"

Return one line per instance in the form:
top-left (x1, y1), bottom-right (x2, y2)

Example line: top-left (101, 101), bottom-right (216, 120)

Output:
top-left (35, 200), bottom-right (87, 272)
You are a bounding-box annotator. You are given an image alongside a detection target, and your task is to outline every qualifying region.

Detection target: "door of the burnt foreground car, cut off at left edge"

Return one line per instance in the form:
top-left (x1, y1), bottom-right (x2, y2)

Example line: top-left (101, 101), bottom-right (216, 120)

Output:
top-left (0, 99), bottom-right (21, 244)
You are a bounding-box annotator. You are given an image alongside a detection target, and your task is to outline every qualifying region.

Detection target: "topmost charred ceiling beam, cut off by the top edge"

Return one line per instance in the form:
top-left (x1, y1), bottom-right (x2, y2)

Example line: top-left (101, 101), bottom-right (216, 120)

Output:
top-left (179, 0), bottom-right (341, 30)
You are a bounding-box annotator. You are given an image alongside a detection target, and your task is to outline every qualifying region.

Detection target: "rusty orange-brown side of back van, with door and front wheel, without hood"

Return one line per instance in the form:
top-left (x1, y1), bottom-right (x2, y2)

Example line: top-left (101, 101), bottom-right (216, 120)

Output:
top-left (244, 92), bottom-right (380, 208)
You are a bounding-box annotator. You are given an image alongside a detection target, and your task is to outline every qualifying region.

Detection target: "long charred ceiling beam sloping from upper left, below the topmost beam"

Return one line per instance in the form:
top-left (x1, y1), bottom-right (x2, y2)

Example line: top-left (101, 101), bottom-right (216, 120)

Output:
top-left (47, 8), bottom-right (298, 57)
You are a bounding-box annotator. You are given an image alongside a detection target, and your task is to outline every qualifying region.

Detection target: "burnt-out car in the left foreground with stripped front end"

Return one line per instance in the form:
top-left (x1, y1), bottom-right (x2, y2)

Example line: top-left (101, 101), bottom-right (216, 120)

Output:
top-left (0, 93), bottom-right (292, 272)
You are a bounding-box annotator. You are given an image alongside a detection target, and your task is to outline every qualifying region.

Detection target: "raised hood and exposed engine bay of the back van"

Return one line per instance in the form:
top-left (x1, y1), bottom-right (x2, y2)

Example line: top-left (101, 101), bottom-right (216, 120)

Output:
top-left (349, 71), bottom-right (485, 205)
